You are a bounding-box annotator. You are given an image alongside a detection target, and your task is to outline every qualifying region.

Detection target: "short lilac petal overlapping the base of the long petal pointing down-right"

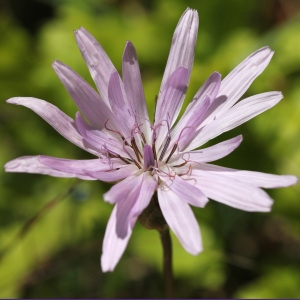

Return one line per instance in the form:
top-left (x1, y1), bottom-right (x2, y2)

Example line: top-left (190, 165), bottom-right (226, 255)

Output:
top-left (160, 175), bottom-right (208, 207)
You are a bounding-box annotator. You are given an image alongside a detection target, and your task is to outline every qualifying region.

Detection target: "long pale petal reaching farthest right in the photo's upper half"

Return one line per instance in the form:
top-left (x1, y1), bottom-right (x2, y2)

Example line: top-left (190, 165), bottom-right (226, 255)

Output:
top-left (186, 92), bottom-right (282, 151)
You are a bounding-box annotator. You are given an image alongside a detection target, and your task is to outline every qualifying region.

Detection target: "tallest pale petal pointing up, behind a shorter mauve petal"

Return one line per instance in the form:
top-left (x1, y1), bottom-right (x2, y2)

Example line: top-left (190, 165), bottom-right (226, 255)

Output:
top-left (160, 8), bottom-right (199, 90)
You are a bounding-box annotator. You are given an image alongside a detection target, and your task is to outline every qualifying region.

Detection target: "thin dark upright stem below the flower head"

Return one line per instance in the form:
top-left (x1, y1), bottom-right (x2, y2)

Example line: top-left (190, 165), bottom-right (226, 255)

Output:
top-left (159, 228), bottom-right (173, 298)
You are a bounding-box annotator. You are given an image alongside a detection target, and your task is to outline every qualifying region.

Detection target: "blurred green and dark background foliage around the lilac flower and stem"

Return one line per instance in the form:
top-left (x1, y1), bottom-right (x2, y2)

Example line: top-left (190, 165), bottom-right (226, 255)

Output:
top-left (0, 0), bottom-right (300, 298)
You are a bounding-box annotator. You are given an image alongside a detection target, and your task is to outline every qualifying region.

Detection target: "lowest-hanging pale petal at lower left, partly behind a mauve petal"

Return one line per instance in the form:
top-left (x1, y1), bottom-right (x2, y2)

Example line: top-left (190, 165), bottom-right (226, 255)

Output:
top-left (101, 206), bottom-right (137, 272)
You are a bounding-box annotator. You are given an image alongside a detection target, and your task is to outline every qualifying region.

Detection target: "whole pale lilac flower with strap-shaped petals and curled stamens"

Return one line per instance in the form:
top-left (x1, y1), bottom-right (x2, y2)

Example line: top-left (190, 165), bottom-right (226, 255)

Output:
top-left (5, 9), bottom-right (297, 271)
